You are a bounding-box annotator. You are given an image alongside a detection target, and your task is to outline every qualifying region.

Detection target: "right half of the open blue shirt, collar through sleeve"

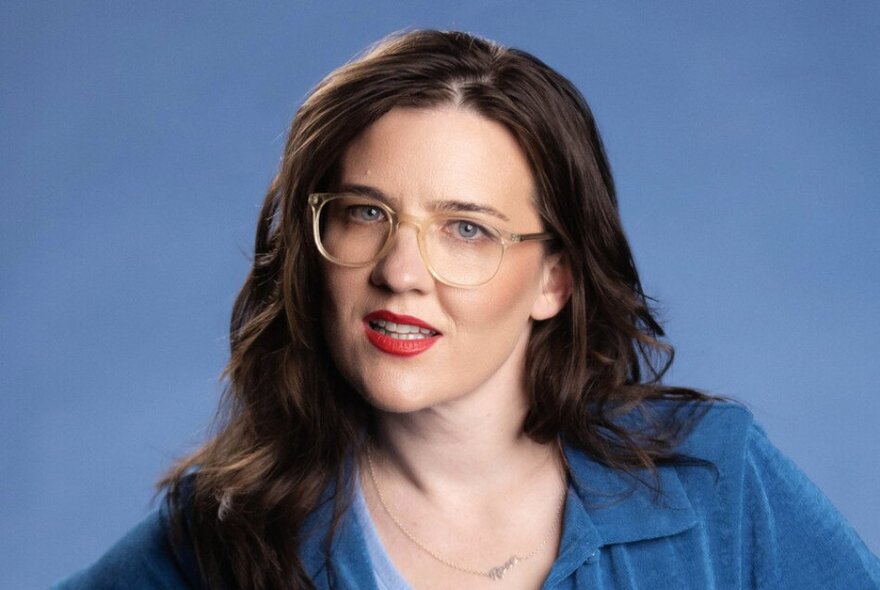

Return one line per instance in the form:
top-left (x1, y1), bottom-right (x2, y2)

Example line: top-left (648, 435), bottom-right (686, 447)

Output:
top-left (566, 400), bottom-right (880, 589)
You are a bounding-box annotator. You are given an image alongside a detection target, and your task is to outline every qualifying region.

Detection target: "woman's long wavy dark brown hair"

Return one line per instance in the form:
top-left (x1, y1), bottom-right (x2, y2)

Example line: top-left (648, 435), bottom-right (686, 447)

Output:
top-left (160, 31), bottom-right (720, 589)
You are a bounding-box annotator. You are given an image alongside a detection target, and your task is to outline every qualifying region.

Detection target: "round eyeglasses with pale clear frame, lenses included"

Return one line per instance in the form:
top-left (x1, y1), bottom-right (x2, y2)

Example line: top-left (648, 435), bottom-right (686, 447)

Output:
top-left (309, 193), bottom-right (554, 287)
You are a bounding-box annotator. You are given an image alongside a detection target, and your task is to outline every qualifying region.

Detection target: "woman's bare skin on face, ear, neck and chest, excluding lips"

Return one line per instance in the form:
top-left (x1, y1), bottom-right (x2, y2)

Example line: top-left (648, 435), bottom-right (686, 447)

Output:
top-left (324, 106), bottom-right (570, 588)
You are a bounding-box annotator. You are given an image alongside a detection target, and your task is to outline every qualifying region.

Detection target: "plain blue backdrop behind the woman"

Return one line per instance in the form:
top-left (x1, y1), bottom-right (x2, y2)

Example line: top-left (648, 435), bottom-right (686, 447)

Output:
top-left (0, 0), bottom-right (880, 588)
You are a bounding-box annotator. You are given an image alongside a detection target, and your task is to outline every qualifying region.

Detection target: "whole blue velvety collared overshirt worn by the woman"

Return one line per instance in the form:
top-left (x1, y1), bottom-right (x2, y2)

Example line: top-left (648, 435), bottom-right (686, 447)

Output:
top-left (56, 404), bottom-right (880, 590)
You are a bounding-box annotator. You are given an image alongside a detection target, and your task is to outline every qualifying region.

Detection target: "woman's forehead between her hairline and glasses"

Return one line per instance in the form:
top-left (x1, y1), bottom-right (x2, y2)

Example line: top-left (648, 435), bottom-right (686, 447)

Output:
top-left (339, 106), bottom-right (535, 219)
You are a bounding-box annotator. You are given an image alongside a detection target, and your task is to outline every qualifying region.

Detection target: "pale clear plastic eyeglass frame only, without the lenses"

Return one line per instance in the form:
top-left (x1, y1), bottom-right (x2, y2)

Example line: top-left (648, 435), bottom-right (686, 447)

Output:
top-left (308, 193), bottom-right (555, 289)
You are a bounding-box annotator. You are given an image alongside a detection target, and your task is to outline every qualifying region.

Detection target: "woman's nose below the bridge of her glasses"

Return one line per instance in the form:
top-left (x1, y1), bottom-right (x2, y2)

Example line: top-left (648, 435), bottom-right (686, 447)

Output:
top-left (370, 223), bottom-right (434, 293)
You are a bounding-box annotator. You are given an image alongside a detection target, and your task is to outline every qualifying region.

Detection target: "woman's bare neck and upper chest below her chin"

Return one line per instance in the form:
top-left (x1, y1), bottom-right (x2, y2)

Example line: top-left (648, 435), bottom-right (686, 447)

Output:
top-left (361, 380), bottom-right (567, 587)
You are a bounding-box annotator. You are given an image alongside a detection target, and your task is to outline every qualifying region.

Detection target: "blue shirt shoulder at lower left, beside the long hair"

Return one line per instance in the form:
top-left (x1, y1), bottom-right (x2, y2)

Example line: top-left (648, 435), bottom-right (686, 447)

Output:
top-left (52, 486), bottom-right (200, 590)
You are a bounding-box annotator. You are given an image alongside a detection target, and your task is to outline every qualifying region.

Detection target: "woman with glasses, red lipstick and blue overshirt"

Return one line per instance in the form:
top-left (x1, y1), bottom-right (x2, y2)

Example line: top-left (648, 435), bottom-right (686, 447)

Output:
top-left (62, 31), bottom-right (880, 589)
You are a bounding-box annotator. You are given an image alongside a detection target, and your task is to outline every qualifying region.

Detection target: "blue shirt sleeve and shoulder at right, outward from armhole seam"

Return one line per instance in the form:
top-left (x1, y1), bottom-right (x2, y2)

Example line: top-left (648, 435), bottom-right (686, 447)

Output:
top-left (674, 403), bottom-right (880, 588)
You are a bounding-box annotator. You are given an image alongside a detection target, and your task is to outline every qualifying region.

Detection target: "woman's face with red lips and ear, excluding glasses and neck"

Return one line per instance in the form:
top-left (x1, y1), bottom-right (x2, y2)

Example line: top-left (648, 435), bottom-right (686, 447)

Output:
top-left (323, 106), bottom-right (568, 413)
